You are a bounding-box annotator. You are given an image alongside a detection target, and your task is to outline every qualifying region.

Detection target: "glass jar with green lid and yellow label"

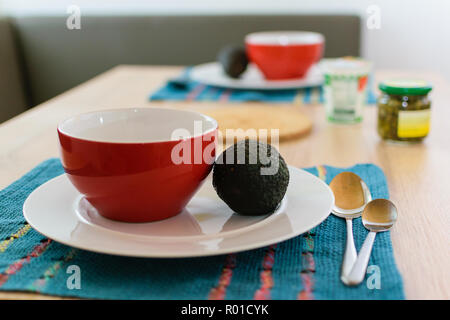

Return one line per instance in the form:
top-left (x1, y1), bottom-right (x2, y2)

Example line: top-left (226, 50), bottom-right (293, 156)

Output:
top-left (377, 80), bottom-right (432, 143)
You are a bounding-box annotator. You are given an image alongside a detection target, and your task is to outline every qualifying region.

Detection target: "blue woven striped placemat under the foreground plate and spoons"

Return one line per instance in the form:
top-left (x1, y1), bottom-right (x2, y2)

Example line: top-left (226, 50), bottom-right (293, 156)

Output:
top-left (0, 159), bottom-right (404, 299)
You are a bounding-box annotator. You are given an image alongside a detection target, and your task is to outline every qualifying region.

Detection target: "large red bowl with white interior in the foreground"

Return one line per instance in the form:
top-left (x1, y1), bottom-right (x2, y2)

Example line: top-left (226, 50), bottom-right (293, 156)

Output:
top-left (58, 108), bottom-right (217, 222)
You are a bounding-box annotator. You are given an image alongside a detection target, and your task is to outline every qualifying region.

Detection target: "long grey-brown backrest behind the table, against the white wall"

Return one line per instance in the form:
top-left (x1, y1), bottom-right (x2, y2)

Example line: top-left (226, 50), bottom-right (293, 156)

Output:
top-left (9, 15), bottom-right (360, 104)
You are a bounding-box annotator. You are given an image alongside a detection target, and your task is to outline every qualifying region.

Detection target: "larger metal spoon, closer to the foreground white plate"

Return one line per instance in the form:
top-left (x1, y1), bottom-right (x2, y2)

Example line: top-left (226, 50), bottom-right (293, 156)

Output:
top-left (330, 172), bottom-right (372, 284)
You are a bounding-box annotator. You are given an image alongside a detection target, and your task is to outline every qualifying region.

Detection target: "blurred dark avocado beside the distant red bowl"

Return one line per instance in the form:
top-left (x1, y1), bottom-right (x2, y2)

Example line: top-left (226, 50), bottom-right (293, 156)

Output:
top-left (217, 46), bottom-right (248, 78)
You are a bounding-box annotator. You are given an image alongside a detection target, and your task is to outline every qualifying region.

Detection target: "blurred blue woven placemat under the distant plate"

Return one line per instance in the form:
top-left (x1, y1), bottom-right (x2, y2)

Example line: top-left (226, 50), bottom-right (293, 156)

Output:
top-left (149, 68), bottom-right (376, 104)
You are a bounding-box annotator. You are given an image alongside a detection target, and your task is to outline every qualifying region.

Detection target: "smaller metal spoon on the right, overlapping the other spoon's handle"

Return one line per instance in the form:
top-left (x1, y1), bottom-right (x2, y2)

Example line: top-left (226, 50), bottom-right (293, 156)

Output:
top-left (347, 199), bottom-right (397, 285)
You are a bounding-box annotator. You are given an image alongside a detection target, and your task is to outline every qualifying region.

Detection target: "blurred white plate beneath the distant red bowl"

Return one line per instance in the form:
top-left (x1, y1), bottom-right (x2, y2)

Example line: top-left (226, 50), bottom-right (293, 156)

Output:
top-left (189, 62), bottom-right (323, 90)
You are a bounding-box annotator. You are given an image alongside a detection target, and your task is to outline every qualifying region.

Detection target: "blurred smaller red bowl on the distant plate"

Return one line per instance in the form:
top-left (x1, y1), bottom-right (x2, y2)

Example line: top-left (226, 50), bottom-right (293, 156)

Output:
top-left (245, 31), bottom-right (325, 80)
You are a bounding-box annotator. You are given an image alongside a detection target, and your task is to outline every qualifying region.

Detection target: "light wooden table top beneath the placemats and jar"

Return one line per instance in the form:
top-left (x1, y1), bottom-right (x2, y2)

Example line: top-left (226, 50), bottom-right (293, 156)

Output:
top-left (0, 66), bottom-right (450, 299)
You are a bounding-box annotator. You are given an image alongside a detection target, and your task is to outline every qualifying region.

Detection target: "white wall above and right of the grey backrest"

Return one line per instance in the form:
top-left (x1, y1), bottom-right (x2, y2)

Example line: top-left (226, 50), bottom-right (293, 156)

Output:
top-left (0, 0), bottom-right (450, 79)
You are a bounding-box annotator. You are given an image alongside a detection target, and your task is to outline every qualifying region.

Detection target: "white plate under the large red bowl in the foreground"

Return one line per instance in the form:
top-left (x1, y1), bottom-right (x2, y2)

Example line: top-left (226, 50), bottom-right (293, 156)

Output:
top-left (23, 167), bottom-right (334, 258)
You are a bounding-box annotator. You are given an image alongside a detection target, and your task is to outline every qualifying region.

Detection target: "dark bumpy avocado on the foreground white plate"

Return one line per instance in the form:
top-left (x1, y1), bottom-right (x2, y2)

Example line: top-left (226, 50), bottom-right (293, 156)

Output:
top-left (213, 140), bottom-right (289, 216)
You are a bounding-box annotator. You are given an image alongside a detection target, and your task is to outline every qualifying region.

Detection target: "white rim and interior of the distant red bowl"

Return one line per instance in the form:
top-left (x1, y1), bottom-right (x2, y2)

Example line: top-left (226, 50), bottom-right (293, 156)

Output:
top-left (245, 31), bottom-right (325, 46)
